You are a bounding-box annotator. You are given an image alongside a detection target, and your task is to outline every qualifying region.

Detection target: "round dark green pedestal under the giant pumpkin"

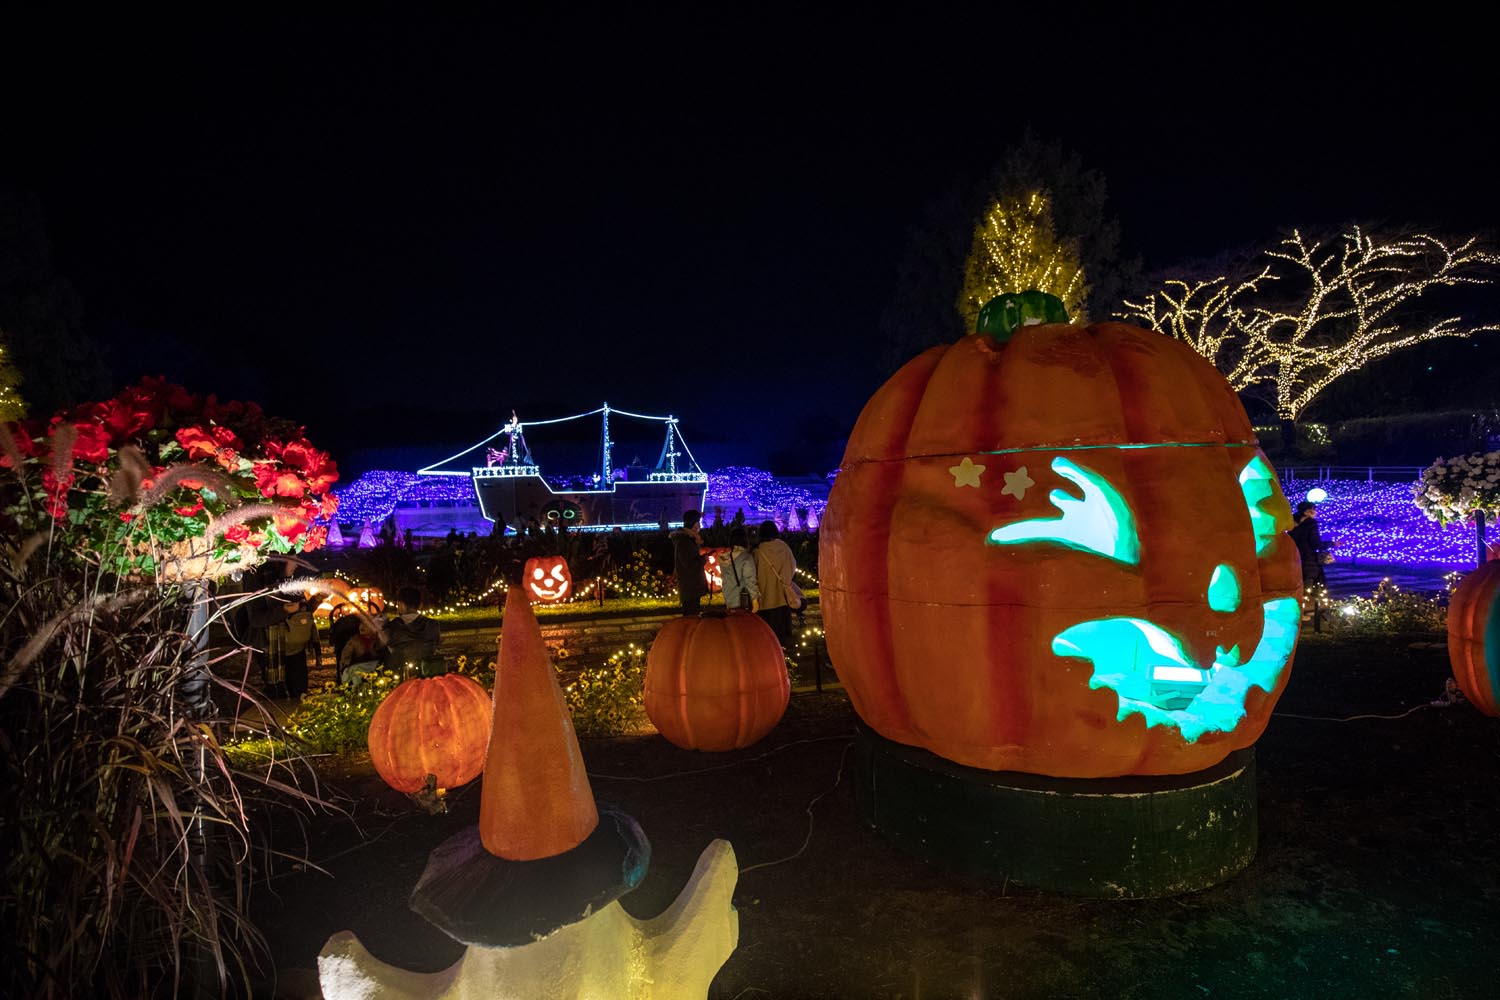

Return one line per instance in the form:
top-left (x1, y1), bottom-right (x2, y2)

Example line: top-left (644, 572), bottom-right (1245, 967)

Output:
top-left (855, 726), bottom-right (1256, 898)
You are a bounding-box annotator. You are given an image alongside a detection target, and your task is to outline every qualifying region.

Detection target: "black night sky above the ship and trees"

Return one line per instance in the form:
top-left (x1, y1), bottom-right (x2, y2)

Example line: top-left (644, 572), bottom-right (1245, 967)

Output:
top-left (0, 4), bottom-right (1500, 472)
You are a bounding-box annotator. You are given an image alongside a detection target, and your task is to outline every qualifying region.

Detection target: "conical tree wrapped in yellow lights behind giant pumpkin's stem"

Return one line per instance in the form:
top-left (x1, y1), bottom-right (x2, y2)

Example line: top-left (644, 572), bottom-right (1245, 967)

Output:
top-left (959, 190), bottom-right (1089, 331)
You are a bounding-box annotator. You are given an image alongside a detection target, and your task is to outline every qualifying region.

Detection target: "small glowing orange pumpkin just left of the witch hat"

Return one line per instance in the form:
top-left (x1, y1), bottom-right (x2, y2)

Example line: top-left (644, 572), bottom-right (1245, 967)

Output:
top-left (369, 673), bottom-right (489, 795)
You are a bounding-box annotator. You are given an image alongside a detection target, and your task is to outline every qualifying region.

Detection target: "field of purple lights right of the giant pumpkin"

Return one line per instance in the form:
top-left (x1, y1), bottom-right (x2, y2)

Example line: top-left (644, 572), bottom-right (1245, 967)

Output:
top-left (1281, 480), bottom-right (1475, 570)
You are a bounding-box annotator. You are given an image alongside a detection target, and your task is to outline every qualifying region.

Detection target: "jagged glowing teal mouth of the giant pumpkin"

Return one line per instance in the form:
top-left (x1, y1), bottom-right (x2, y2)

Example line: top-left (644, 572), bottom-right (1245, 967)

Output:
top-left (1052, 597), bottom-right (1302, 744)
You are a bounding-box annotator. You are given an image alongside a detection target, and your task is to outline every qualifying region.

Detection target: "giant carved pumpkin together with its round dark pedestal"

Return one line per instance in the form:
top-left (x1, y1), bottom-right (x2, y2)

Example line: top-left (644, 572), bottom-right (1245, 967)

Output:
top-left (819, 292), bottom-right (1301, 897)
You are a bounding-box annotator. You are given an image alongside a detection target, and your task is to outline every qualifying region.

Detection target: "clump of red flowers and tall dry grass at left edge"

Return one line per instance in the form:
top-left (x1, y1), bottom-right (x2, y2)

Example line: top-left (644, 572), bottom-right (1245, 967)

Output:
top-left (0, 381), bottom-right (335, 997)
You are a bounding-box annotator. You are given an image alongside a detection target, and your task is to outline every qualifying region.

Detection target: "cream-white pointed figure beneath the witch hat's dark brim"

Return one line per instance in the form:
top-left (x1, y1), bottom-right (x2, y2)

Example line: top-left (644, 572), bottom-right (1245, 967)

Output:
top-left (318, 840), bottom-right (740, 1000)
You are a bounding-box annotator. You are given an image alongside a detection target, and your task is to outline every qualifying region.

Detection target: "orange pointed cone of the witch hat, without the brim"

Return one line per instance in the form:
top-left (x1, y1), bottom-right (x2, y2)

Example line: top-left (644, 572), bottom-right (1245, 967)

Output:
top-left (479, 586), bottom-right (599, 861)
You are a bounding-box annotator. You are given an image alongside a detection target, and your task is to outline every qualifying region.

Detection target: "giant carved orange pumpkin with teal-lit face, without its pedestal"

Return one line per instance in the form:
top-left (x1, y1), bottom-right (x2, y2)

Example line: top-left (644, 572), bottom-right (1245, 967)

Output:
top-left (819, 292), bottom-right (1301, 778)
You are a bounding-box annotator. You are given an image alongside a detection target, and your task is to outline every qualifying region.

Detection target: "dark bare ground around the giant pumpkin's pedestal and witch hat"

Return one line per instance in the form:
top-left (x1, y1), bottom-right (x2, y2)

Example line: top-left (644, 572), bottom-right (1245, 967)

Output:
top-left (255, 637), bottom-right (1500, 1000)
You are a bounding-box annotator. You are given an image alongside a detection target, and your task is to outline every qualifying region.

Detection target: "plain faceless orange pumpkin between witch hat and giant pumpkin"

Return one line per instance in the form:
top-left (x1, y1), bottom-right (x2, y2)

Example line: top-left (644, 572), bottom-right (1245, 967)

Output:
top-left (645, 613), bottom-right (792, 750)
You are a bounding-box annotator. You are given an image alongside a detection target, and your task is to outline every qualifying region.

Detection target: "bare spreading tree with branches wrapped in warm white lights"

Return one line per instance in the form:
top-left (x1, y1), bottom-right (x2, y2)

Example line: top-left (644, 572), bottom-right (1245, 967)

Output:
top-left (1122, 226), bottom-right (1500, 445)
